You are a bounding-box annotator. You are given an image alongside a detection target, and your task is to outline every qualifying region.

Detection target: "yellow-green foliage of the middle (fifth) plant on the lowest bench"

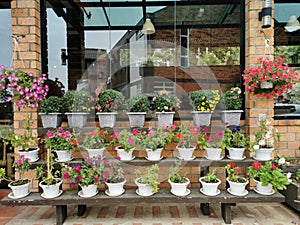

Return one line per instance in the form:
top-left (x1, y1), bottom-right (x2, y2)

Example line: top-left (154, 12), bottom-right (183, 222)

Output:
top-left (134, 164), bottom-right (159, 193)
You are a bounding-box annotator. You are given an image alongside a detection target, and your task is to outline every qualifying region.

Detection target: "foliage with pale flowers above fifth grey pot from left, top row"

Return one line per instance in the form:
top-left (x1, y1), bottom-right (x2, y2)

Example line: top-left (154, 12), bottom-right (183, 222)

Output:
top-left (153, 91), bottom-right (181, 112)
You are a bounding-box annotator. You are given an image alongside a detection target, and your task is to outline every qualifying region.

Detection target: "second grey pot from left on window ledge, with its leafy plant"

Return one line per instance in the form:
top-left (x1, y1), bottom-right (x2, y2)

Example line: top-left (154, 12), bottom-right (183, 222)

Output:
top-left (65, 90), bottom-right (92, 128)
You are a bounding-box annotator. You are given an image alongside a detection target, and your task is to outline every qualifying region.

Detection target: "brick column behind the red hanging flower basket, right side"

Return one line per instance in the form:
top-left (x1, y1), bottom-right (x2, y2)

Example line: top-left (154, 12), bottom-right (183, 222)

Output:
top-left (245, 0), bottom-right (274, 146)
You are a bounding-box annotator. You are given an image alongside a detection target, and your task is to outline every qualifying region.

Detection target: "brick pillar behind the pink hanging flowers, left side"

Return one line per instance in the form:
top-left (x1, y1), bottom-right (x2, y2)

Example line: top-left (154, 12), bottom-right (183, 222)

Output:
top-left (11, 0), bottom-right (41, 192)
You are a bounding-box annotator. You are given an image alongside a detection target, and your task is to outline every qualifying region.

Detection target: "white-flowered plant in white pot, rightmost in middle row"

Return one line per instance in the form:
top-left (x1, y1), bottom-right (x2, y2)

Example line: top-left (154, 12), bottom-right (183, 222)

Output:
top-left (250, 119), bottom-right (281, 161)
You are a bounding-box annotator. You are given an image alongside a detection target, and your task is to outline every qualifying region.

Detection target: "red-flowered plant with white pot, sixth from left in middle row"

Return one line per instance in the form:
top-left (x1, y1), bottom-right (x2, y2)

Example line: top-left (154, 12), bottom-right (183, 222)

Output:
top-left (177, 124), bottom-right (200, 160)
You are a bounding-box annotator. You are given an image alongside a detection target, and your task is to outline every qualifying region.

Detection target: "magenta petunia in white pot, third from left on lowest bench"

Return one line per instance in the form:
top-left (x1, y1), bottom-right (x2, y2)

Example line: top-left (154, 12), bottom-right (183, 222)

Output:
top-left (63, 156), bottom-right (103, 198)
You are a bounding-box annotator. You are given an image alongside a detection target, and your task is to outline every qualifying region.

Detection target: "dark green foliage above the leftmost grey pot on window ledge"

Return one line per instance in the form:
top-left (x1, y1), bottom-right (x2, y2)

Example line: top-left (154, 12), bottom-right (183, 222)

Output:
top-left (40, 96), bottom-right (65, 114)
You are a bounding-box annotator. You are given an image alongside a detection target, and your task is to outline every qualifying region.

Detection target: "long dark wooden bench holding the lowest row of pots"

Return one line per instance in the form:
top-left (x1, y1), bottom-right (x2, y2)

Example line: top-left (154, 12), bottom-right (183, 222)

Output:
top-left (1, 189), bottom-right (285, 225)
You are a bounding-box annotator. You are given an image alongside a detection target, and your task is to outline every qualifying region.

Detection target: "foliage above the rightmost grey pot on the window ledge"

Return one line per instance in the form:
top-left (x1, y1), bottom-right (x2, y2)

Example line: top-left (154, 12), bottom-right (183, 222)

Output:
top-left (221, 87), bottom-right (243, 110)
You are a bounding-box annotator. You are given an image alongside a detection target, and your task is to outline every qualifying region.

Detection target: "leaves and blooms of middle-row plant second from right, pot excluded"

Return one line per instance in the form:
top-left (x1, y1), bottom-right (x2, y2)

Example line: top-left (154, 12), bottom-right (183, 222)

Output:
top-left (223, 126), bottom-right (248, 148)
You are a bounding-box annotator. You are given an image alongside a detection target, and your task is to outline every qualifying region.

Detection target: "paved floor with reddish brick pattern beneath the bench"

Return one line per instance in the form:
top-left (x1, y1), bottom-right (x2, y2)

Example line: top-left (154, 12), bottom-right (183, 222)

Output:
top-left (0, 190), bottom-right (300, 225)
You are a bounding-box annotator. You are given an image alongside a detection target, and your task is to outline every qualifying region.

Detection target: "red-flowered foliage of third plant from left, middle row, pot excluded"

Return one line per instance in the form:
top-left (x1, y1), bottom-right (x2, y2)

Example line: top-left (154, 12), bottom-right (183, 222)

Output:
top-left (82, 127), bottom-right (109, 149)
